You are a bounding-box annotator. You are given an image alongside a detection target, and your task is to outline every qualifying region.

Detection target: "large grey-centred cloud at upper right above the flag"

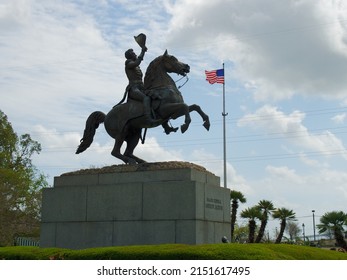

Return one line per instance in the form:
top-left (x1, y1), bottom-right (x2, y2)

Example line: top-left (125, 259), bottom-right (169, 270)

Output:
top-left (169, 0), bottom-right (347, 101)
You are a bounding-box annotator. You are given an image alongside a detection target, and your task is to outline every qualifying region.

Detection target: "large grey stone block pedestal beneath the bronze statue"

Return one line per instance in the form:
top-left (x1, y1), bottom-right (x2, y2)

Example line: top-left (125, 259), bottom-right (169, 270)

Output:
top-left (40, 164), bottom-right (230, 249)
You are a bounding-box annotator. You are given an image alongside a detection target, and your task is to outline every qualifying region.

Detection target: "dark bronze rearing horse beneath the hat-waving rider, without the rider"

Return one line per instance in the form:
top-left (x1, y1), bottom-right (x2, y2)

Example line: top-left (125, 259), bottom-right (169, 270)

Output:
top-left (76, 51), bottom-right (210, 164)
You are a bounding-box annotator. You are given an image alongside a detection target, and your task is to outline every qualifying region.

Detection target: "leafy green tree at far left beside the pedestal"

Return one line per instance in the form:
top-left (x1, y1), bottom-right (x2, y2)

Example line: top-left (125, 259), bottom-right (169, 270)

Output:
top-left (0, 110), bottom-right (47, 246)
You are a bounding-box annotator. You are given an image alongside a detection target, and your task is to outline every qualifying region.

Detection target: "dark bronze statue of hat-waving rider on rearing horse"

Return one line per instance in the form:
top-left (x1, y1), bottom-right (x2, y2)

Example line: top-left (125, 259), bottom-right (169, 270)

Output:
top-left (76, 34), bottom-right (210, 164)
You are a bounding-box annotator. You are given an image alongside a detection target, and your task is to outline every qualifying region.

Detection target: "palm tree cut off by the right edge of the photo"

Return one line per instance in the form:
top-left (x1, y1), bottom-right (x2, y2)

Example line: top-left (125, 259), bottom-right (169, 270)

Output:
top-left (317, 211), bottom-right (347, 250)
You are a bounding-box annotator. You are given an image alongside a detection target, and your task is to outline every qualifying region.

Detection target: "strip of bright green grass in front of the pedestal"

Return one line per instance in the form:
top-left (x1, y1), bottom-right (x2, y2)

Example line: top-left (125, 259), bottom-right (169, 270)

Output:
top-left (0, 243), bottom-right (347, 260)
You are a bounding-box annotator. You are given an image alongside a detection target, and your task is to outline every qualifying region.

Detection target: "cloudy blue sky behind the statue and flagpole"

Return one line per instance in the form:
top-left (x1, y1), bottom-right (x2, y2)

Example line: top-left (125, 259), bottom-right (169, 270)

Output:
top-left (0, 0), bottom-right (347, 240)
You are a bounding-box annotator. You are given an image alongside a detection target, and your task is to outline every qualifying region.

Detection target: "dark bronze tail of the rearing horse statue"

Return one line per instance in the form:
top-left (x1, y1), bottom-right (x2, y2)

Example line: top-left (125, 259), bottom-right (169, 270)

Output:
top-left (76, 111), bottom-right (106, 154)
